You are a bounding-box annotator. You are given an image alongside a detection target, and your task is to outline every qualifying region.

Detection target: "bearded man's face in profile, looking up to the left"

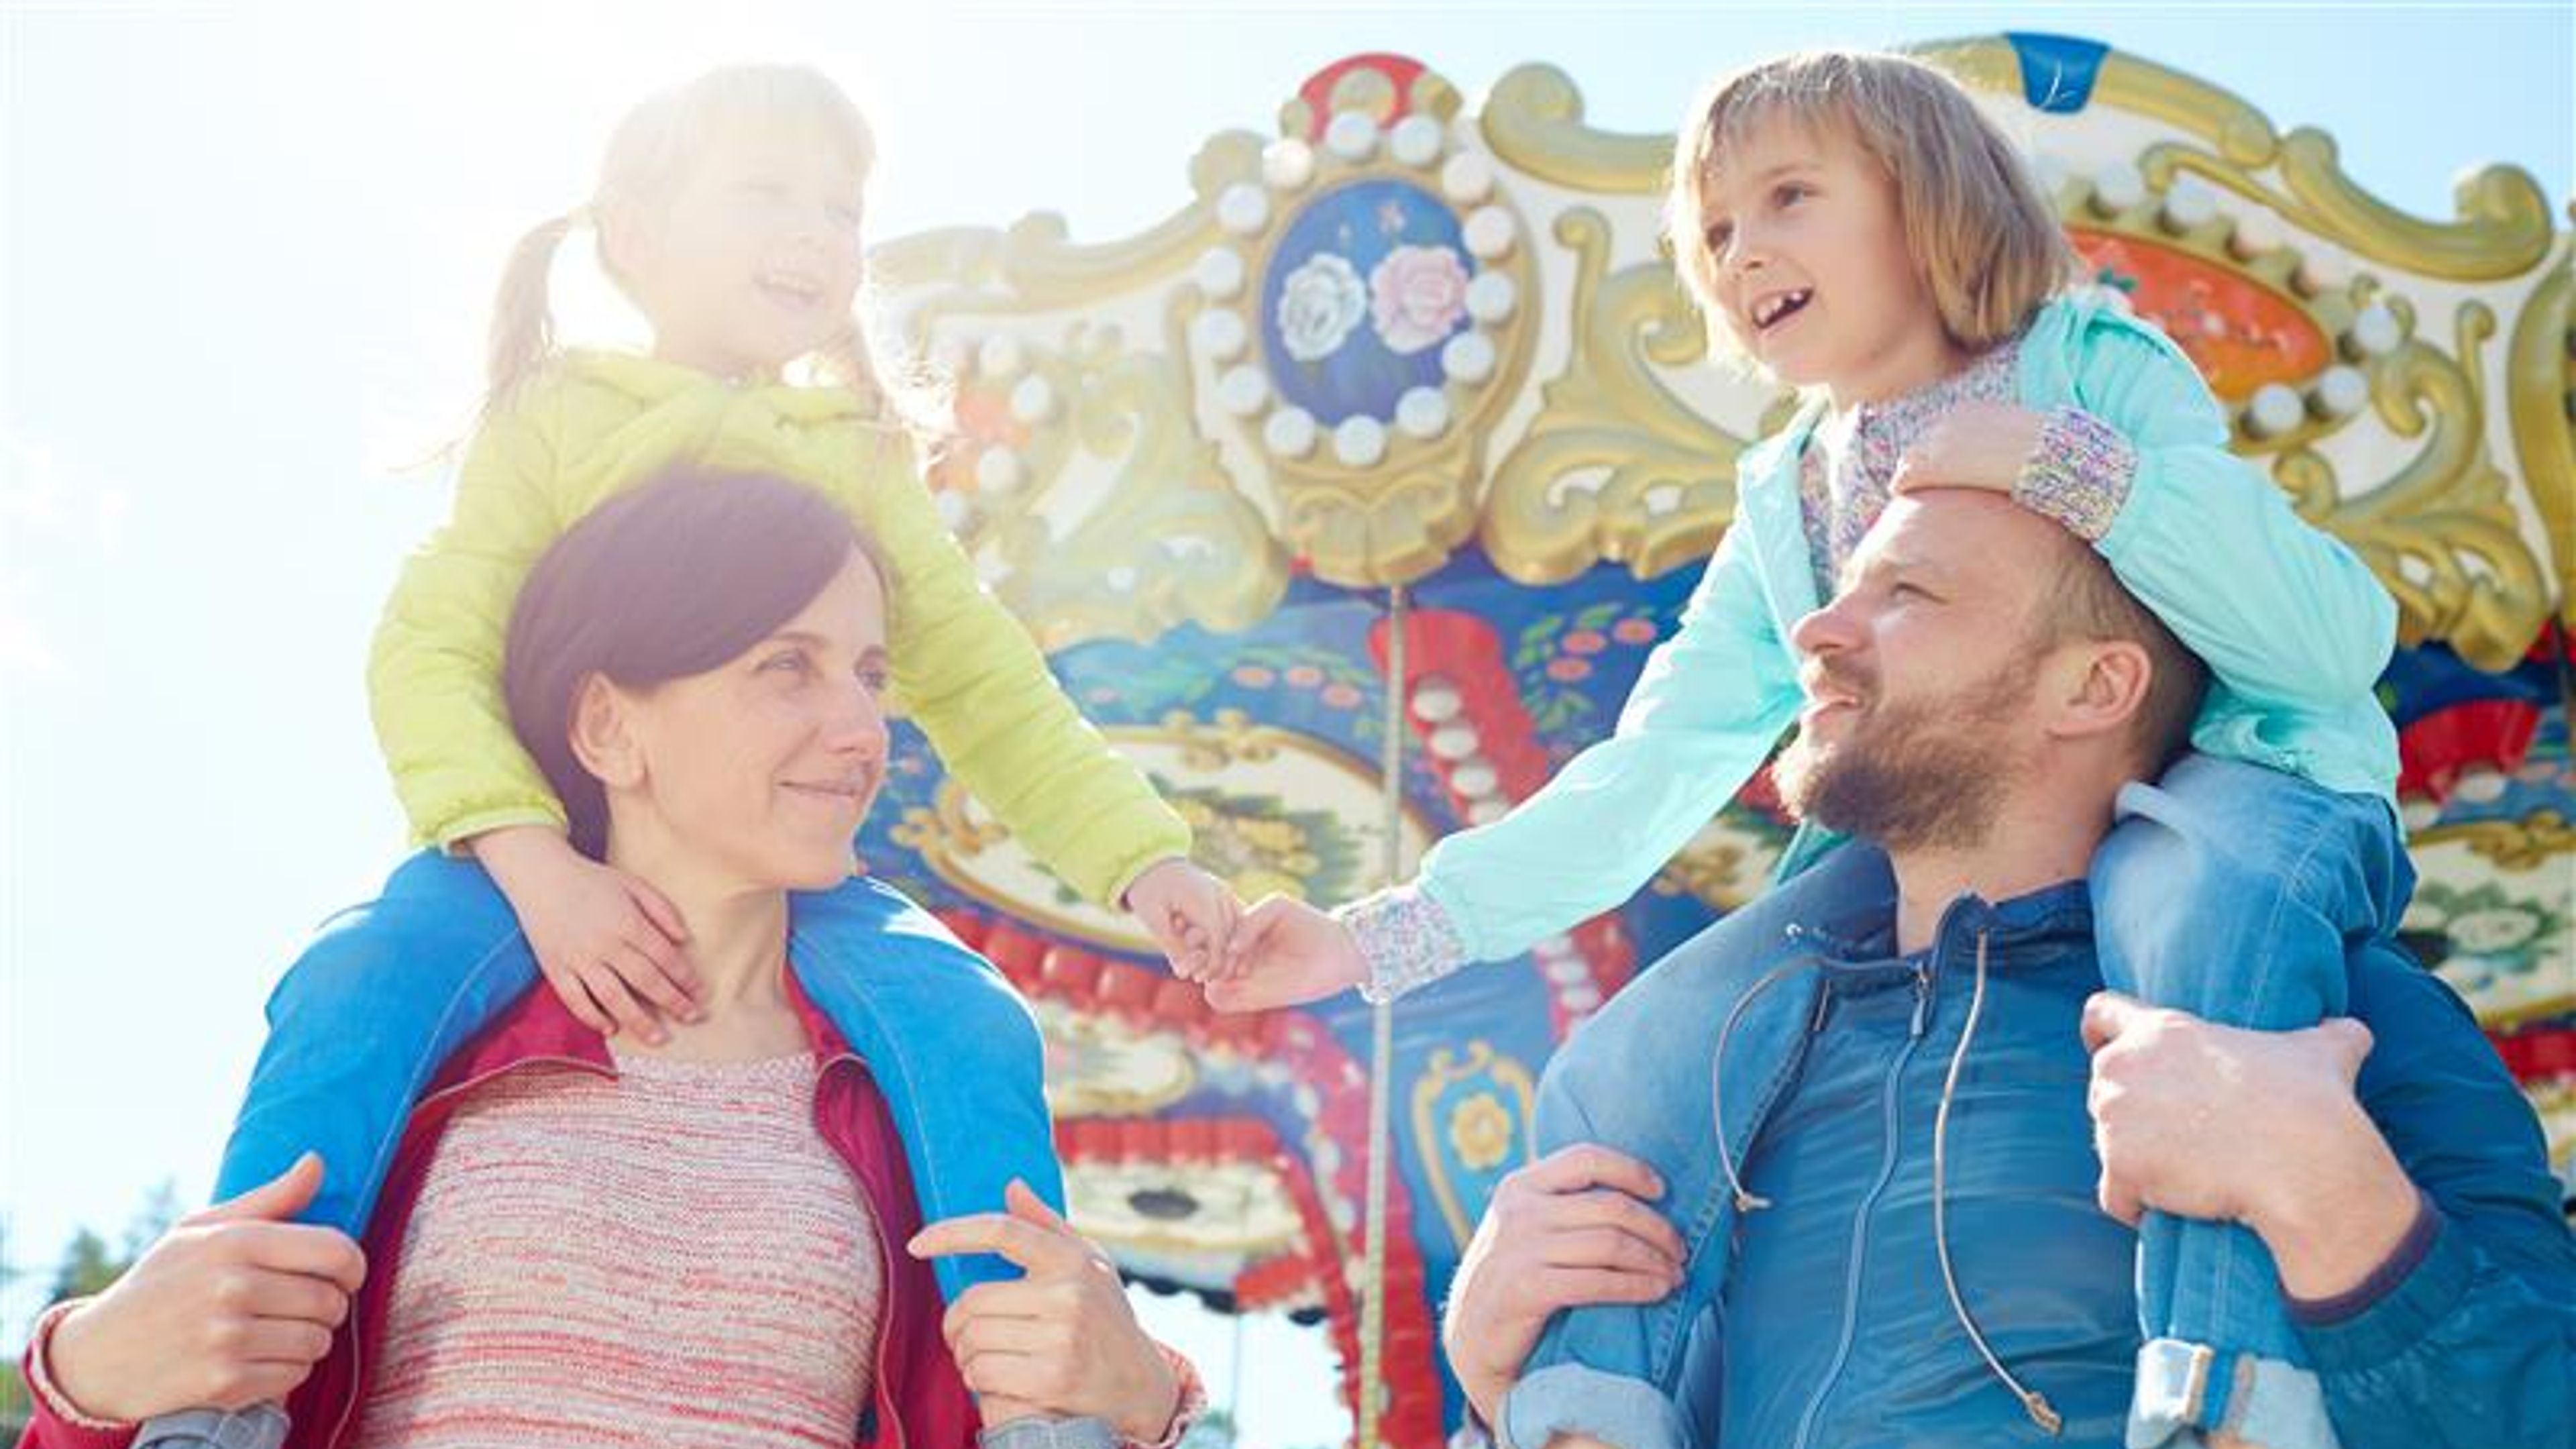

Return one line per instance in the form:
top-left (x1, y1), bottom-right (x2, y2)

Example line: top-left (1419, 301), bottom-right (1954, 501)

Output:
top-left (1775, 490), bottom-right (2051, 851)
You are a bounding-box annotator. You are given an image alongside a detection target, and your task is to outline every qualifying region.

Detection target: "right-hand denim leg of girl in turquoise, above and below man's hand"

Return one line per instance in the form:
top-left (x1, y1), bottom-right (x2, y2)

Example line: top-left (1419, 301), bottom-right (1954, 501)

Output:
top-left (2092, 753), bottom-right (2414, 1446)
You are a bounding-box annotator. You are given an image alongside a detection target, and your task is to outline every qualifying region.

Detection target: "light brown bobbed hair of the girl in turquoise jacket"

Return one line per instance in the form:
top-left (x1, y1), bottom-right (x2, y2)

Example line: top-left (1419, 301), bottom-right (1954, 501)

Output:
top-left (1664, 52), bottom-right (2076, 366)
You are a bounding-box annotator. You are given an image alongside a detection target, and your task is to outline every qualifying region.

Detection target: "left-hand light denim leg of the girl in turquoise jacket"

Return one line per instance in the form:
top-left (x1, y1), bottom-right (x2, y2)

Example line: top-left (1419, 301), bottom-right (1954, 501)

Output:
top-left (1499, 846), bottom-right (1888, 1449)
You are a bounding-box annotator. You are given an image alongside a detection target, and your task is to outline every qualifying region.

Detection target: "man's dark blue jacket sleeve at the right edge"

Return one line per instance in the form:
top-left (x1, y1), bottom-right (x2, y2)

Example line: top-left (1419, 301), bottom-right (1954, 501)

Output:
top-left (2300, 947), bottom-right (2576, 1449)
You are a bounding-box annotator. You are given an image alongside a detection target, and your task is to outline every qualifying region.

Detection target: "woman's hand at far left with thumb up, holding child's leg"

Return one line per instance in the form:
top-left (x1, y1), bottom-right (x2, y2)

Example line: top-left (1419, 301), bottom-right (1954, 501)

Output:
top-left (44, 1152), bottom-right (366, 1424)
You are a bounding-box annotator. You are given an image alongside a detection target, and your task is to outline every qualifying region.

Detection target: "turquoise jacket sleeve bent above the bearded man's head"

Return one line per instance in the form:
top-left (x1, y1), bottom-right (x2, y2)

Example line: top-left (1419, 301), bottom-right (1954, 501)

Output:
top-left (2074, 315), bottom-right (2396, 709)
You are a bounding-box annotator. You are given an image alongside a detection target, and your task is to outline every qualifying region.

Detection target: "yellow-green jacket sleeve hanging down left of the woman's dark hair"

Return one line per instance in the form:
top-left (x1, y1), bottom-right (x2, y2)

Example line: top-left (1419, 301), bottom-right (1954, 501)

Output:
top-left (366, 394), bottom-right (564, 848)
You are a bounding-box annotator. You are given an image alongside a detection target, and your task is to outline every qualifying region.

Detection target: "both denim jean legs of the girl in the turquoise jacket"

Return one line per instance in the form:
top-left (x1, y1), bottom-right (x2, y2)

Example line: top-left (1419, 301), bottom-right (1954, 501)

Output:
top-left (1502, 753), bottom-right (2414, 1449)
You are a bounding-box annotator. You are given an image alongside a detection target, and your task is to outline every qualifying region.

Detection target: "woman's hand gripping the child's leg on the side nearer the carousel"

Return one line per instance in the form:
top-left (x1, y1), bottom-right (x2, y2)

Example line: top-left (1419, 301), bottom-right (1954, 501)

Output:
top-left (910, 1181), bottom-right (1180, 1444)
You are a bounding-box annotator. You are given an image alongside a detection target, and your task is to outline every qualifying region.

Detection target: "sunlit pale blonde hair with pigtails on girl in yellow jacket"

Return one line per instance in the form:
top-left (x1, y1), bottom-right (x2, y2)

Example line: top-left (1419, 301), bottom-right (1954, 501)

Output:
top-left (484, 64), bottom-right (914, 418)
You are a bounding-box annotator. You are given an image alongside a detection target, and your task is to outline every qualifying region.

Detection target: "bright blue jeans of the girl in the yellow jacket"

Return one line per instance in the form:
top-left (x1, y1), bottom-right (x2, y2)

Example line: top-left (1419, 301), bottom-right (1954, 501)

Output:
top-left (142, 851), bottom-right (1064, 1444)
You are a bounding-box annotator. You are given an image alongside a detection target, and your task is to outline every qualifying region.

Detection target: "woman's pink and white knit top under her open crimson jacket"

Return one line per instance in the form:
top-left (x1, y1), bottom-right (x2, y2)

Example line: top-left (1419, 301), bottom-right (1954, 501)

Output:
top-left (358, 1055), bottom-right (883, 1449)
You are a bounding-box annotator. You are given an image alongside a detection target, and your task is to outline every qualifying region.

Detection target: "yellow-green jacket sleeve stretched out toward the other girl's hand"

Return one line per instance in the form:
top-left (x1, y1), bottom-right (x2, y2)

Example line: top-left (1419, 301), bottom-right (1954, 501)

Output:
top-left (861, 430), bottom-right (1190, 908)
